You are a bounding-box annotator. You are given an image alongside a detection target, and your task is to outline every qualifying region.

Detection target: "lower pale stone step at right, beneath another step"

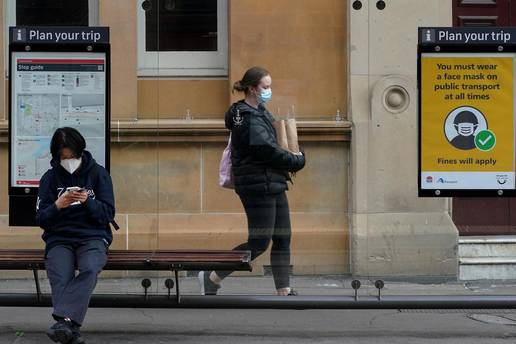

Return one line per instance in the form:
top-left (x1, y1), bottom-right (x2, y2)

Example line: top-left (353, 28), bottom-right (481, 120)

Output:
top-left (459, 257), bottom-right (516, 281)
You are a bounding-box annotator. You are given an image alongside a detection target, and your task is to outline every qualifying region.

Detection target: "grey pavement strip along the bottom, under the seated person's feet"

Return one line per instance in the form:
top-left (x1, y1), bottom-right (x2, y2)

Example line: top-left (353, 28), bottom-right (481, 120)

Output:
top-left (0, 307), bottom-right (516, 344)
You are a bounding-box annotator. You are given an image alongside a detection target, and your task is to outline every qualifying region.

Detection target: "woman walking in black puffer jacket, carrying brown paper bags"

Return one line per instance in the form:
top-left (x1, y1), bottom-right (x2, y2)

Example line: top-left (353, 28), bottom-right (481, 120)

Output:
top-left (199, 67), bottom-right (305, 295)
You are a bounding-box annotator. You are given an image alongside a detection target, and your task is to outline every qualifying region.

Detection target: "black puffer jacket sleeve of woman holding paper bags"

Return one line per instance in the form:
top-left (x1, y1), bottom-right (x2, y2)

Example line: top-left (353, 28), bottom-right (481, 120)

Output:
top-left (249, 116), bottom-right (305, 172)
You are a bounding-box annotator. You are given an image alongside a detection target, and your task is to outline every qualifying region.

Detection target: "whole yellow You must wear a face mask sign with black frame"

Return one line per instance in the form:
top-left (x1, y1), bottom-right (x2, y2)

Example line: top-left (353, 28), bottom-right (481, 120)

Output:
top-left (418, 28), bottom-right (516, 197)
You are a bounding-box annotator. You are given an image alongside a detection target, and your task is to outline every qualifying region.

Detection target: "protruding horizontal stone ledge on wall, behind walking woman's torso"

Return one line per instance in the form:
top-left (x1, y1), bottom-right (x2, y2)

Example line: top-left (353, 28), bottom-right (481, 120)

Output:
top-left (0, 119), bottom-right (352, 142)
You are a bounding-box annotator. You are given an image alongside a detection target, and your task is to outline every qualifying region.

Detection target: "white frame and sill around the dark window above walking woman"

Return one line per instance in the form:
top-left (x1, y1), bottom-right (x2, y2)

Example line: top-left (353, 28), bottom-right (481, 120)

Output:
top-left (136, 0), bottom-right (229, 77)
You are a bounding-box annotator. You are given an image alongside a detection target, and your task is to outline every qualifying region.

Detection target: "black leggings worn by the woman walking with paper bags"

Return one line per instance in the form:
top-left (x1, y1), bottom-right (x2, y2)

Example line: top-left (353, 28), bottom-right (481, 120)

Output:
top-left (216, 192), bottom-right (291, 289)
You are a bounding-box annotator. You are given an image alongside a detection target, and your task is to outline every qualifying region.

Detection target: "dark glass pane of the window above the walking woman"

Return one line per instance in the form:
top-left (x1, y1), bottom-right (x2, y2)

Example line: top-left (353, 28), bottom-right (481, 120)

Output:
top-left (145, 0), bottom-right (217, 51)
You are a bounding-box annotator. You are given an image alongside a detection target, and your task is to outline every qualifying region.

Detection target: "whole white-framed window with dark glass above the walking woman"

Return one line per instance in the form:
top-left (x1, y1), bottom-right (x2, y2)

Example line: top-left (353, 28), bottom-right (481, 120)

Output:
top-left (137, 0), bottom-right (228, 76)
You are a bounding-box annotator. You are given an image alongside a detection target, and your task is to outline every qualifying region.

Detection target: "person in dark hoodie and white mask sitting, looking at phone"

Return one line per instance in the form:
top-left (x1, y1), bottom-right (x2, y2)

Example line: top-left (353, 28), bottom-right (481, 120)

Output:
top-left (36, 127), bottom-right (115, 344)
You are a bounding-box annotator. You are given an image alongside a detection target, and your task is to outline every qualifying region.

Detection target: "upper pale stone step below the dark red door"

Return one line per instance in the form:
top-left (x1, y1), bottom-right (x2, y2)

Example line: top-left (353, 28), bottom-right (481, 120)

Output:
top-left (458, 235), bottom-right (516, 258)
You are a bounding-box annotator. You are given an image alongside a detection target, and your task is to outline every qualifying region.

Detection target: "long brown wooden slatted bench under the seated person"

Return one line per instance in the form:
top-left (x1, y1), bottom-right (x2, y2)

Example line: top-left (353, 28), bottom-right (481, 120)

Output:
top-left (0, 250), bottom-right (252, 303)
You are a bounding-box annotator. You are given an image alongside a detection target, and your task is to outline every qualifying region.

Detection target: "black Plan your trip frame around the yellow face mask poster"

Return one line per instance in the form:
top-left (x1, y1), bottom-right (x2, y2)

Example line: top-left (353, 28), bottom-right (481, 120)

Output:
top-left (417, 27), bottom-right (516, 197)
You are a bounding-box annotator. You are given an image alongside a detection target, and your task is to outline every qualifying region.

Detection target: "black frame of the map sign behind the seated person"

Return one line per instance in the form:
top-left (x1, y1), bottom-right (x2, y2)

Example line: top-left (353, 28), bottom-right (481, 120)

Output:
top-left (7, 27), bottom-right (111, 226)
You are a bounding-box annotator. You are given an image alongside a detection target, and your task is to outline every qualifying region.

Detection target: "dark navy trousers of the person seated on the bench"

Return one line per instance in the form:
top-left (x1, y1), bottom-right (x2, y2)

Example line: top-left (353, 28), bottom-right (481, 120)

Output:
top-left (45, 239), bottom-right (107, 325)
